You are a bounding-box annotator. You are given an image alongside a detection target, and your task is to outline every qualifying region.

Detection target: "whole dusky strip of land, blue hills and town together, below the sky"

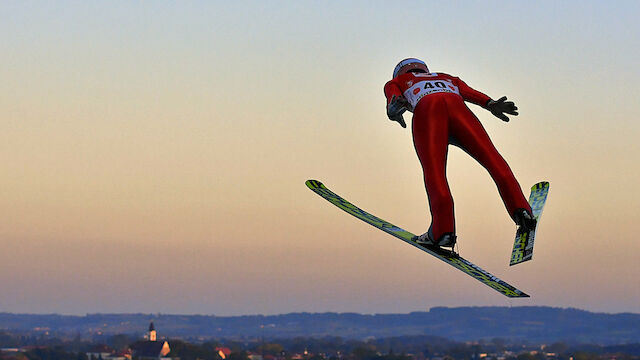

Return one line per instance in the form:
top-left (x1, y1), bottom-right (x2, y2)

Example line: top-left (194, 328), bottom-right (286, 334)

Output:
top-left (0, 307), bottom-right (640, 360)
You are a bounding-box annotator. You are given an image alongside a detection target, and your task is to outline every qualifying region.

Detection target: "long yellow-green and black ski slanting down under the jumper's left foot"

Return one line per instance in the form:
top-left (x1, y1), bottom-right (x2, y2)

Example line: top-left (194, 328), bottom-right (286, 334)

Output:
top-left (306, 180), bottom-right (529, 298)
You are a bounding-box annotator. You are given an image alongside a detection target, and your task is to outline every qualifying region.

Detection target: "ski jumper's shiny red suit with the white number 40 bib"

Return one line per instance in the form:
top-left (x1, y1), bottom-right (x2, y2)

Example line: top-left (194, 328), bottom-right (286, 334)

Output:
top-left (384, 72), bottom-right (531, 240)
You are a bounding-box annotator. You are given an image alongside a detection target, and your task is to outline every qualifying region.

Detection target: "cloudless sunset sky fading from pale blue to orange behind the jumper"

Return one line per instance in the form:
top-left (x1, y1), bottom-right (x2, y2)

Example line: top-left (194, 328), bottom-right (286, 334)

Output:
top-left (0, 1), bottom-right (640, 315)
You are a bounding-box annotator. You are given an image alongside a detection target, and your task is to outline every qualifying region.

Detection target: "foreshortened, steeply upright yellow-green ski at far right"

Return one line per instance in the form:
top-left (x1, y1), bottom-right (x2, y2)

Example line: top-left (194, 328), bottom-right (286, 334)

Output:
top-left (509, 181), bottom-right (549, 266)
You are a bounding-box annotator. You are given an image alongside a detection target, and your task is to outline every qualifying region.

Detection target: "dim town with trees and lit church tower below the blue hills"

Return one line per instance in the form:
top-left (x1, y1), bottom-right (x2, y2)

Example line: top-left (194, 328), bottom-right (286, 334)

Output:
top-left (0, 322), bottom-right (640, 360)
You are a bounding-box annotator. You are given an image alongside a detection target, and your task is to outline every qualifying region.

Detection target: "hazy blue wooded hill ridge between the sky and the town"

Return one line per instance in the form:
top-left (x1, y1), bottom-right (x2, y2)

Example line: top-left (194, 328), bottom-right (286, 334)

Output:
top-left (0, 306), bottom-right (640, 345)
